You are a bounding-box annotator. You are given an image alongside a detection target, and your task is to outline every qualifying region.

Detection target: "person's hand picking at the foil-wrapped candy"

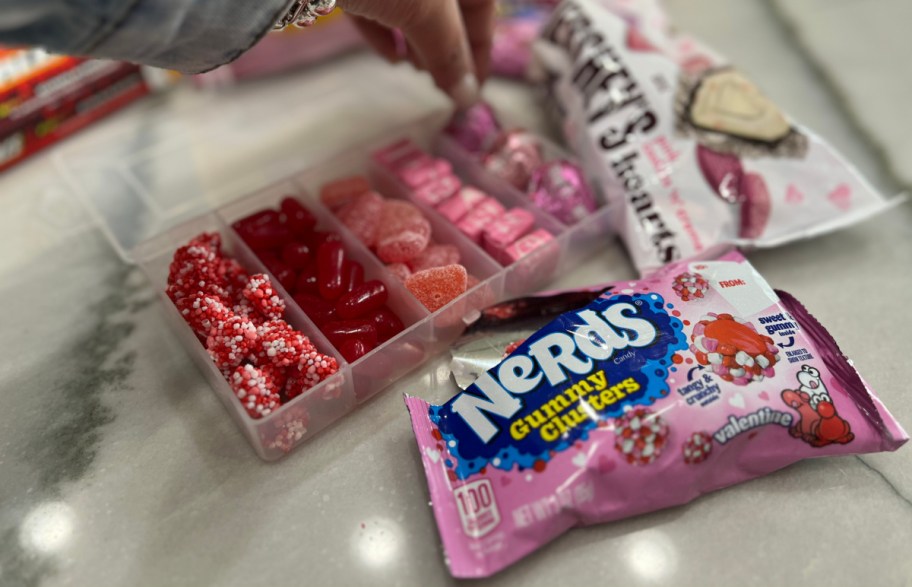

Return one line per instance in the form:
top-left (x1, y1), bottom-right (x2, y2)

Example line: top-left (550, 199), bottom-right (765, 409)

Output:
top-left (338, 0), bottom-right (494, 108)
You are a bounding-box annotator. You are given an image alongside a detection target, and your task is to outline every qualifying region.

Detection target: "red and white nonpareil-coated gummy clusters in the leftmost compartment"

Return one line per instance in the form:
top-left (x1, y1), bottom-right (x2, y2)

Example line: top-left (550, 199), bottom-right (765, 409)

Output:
top-left (167, 233), bottom-right (339, 418)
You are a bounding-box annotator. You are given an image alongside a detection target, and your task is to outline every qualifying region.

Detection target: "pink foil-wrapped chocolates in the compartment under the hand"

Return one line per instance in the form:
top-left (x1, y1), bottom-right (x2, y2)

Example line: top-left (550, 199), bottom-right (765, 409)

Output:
top-left (446, 103), bottom-right (598, 225)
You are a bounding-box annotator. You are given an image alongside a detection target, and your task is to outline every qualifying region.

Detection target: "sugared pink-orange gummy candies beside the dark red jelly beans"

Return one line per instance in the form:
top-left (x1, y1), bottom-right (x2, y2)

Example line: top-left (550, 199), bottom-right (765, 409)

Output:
top-left (321, 173), bottom-right (478, 312)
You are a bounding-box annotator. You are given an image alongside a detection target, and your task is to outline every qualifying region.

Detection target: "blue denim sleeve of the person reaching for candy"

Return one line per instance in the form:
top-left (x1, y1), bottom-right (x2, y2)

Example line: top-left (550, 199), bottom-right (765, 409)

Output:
top-left (0, 0), bottom-right (291, 73)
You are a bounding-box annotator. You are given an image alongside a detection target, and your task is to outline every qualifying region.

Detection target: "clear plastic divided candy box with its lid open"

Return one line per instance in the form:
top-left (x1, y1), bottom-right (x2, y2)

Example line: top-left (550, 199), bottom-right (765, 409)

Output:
top-left (56, 60), bottom-right (615, 461)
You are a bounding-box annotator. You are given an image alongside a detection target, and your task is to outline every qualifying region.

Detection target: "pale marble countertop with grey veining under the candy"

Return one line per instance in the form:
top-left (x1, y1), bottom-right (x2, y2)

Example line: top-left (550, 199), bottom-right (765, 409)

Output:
top-left (0, 0), bottom-right (912, 586)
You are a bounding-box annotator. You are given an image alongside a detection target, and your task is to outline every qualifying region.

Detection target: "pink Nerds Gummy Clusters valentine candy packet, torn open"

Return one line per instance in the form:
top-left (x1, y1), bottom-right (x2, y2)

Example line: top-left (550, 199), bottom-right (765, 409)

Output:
top-left (406, 252), bottom-right (908, 577)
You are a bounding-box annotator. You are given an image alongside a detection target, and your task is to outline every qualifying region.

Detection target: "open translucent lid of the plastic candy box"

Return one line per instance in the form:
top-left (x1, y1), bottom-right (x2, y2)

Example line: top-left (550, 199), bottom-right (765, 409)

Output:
top-left (54, 54), bottom-right (447, 263)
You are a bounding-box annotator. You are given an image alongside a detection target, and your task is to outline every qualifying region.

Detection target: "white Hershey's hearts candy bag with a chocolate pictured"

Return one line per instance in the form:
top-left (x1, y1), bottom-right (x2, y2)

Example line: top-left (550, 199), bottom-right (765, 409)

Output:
top-left (535, 0), bottom-right (900, 274)
